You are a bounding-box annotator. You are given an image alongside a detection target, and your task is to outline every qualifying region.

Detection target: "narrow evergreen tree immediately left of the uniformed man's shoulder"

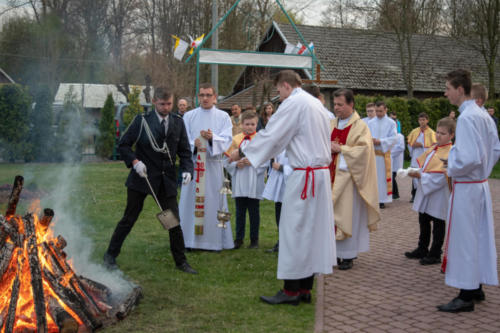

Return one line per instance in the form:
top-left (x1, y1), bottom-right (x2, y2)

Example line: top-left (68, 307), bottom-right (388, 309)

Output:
top-left (96, 94), bottom-right (115, 158)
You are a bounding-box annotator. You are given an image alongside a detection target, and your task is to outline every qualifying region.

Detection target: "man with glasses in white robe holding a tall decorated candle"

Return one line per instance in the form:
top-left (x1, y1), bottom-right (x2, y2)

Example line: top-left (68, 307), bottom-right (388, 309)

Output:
top-left (179, 83), bottom-right (234, 251)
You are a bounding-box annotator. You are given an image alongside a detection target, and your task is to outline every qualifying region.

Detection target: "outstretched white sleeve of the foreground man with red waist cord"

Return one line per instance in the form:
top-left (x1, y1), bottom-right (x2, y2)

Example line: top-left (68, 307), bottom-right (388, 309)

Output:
top-left (242, 100), bottom-right (302, 165)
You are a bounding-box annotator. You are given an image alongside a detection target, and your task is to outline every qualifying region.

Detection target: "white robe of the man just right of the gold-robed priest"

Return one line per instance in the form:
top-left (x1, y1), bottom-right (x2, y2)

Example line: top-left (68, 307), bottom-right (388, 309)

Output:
top-left (368, 115), bottom-right (398, 203)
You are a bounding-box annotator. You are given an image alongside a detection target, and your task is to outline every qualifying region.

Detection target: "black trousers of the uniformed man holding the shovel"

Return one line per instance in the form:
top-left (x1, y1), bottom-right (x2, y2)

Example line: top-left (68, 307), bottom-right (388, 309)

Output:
top-left (108, 187), bottom-right (186, 265)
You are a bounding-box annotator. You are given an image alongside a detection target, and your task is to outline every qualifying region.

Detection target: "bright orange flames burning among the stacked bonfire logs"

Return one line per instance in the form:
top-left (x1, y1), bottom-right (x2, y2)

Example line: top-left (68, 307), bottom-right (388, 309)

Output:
top-left (0, 200), bottom-right (89, 332)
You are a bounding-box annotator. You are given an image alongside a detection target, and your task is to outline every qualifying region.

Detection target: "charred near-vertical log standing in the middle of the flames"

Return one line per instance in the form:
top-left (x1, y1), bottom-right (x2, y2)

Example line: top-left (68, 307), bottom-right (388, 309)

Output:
top-left (23, 214), bottom-right (47, 333)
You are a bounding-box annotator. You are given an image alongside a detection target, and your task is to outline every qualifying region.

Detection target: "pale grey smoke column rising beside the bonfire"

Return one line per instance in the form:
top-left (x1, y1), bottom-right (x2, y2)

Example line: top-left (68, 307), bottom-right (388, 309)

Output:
top-left (31, 87), bottom-right (135, 299)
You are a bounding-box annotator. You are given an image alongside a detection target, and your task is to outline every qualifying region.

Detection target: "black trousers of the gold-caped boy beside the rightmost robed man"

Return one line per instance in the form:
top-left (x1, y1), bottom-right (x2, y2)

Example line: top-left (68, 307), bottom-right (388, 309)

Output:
top-left (418, 213), bottom-right (446, 258)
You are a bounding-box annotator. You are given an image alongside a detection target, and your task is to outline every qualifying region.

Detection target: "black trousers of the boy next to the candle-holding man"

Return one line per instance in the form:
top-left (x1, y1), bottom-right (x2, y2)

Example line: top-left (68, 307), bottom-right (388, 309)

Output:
top-left (234, 197), bottom-right (260, 242)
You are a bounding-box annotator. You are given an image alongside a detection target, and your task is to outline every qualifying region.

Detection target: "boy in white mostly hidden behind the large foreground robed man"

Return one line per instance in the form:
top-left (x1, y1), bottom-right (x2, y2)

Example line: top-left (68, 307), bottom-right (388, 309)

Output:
top-left (262, 150), bottom-right (293, 253)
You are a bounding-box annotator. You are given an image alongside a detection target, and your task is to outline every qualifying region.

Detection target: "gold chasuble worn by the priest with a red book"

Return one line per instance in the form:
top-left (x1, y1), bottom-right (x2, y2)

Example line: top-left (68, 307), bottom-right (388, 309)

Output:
top-left (330, 111), bottom-right (380, 240)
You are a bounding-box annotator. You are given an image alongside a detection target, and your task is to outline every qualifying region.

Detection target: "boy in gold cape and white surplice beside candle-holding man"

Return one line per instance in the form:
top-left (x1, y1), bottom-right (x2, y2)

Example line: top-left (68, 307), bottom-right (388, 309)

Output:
top-left (225, 110), bottom-right (267, 249)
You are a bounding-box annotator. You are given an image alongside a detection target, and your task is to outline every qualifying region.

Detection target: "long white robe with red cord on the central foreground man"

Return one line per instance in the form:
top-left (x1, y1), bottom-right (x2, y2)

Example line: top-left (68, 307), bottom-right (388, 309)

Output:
top-left (243, 88), bottom-right (336, 280)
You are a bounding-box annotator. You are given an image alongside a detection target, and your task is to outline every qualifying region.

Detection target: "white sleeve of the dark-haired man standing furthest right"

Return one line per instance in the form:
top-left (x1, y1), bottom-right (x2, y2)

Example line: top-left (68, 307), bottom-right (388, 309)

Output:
top-left (448, 115), bottom-right (486, 178)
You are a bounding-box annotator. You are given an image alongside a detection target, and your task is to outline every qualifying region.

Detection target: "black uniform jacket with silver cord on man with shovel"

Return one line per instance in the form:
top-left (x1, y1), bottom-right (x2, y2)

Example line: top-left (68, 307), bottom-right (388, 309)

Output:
top-left (118, 111), bottom-right (193, 196)
